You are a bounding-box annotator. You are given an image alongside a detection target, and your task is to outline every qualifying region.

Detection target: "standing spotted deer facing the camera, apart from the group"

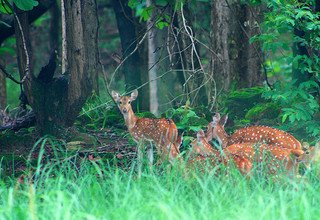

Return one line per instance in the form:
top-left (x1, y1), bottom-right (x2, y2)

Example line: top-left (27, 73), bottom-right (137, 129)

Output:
top-left (111, 90), bottom-right (181, 168)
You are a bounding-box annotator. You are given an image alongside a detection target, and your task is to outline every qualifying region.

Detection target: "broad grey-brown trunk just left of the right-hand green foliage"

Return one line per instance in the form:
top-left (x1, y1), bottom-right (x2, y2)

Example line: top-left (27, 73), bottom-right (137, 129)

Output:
top-left (211, 0), bottom-right (263, 91)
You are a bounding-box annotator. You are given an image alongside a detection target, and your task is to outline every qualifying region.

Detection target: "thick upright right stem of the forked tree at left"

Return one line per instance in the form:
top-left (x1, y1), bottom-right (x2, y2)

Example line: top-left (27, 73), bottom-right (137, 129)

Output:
top-left (65, 0), bottom-right (99, 126)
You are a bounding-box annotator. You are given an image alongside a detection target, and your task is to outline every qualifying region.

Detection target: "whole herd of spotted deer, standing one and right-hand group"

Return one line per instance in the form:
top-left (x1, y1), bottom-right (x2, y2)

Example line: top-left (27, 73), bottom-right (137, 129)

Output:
top-left (112, 90), bottom-right (320, 177)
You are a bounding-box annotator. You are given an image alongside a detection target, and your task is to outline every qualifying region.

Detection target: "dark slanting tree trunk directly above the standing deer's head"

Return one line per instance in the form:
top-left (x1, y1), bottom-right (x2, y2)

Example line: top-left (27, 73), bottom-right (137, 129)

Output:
top-left (112, 0), bottom-right (149, 110)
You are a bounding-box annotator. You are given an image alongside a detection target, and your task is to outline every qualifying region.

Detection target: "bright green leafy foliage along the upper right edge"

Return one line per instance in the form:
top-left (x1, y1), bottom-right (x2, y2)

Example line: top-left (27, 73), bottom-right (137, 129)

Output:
top-left (251, 0), bottom-right (320, 136)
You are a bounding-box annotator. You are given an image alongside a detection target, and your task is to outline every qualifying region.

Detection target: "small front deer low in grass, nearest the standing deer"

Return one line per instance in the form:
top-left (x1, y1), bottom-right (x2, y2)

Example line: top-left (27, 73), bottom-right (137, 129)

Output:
top-left (187, 130), bottom-right (252, 174)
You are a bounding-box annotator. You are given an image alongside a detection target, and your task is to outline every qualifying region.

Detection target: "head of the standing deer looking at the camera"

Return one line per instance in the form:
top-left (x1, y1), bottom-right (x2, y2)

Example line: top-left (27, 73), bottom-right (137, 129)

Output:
top-left (111, 89), bottom-right (138, 116)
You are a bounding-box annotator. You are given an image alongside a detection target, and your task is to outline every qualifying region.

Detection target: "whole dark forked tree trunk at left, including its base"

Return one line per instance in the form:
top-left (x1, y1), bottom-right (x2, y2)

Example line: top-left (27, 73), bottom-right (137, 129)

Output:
top-left (15, 0), bottom-right (98, 135)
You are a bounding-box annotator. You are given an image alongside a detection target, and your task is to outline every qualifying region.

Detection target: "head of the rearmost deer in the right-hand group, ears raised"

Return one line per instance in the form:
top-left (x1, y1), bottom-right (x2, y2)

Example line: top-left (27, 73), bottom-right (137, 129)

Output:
top-left (206, 113), bottom-right (228, 147)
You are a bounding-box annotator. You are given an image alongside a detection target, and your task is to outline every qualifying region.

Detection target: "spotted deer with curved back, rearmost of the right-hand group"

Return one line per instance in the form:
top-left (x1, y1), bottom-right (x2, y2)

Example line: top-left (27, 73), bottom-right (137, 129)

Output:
top-left (206, 113), bottom-right (301, 150)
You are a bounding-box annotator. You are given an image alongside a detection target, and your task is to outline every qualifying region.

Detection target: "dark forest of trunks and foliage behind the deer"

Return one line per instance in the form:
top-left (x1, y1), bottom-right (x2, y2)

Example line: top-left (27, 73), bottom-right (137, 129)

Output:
top-left (0, 0), bottom-right (320, 156)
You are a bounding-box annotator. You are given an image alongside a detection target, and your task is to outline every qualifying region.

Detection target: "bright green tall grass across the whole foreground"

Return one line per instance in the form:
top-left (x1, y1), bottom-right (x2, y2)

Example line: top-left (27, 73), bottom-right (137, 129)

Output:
top-left (0, 140), bottom-right (320, 219)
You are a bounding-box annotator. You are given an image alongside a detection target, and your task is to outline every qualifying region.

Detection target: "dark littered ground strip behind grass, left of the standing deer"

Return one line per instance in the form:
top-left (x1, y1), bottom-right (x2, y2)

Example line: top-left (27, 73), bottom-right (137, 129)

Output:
top-left (0, 125), bottom-right (136, 179)
